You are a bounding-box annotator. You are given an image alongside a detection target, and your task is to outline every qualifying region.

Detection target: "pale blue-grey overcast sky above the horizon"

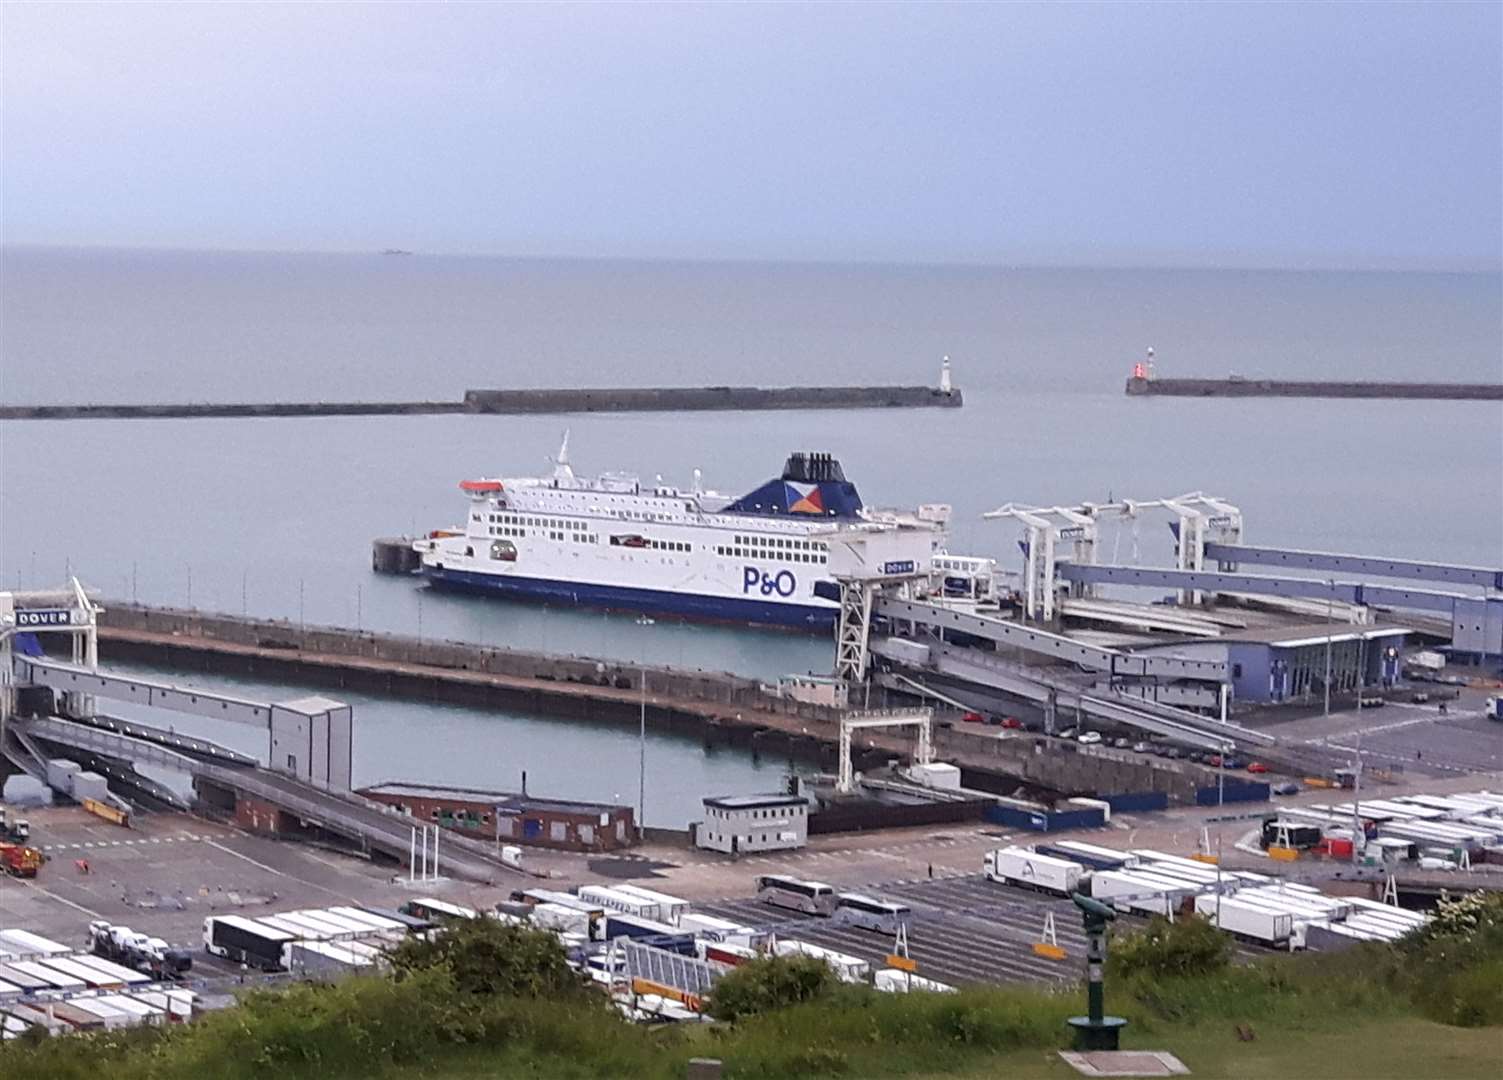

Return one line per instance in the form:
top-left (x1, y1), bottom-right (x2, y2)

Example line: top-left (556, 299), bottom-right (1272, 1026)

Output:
top-left (0, 2), bottom-right (1503, 267)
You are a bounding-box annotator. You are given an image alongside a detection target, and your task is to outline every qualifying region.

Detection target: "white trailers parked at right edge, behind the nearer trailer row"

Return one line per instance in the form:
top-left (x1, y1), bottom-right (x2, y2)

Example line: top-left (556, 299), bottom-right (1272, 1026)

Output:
top-left (1276, 792), bottom-right (1503, 862)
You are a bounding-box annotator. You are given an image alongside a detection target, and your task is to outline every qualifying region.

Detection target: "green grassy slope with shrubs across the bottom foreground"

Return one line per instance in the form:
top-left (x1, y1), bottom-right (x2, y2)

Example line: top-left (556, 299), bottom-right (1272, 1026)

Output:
top-left (0, 897), bottom-right (1503, 1080)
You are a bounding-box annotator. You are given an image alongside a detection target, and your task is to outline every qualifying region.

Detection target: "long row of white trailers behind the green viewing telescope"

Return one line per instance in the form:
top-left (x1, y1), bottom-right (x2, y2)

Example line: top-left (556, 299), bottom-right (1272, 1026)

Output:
top-left (984, 840), bottom-right (1428, 949)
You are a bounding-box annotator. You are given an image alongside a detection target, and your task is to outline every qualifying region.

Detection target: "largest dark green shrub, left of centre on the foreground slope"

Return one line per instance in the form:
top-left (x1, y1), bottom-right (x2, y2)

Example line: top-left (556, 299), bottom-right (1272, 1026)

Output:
top-left (389, 919), bottom-right (585, 999)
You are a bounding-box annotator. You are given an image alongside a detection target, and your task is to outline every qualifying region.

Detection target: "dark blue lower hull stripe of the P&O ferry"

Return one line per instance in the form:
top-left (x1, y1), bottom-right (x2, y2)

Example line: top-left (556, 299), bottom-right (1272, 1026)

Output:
top-left (422, 566), bottom-right (836, 631)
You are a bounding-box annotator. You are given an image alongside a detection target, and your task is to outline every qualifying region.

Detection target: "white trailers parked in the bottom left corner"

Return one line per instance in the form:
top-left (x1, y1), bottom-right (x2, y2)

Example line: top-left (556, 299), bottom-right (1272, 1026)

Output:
top-left (0, 930), bottom-right (195, 1039)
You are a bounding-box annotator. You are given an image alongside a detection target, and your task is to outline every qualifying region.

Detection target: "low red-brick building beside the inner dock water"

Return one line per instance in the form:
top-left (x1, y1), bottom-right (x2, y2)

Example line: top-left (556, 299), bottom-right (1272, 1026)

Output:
top-left (359, 784), bottom-right (637, 852)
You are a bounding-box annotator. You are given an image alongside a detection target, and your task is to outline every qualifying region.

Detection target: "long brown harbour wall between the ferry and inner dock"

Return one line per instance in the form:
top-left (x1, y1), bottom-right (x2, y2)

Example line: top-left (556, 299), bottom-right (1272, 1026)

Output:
top-left (90, 602), bottom-right (1214, 802)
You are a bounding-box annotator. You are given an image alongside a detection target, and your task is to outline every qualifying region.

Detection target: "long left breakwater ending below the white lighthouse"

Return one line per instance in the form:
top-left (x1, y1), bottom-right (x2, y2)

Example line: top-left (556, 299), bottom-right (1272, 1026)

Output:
top-left (0, 386), bottom-right (963, 421)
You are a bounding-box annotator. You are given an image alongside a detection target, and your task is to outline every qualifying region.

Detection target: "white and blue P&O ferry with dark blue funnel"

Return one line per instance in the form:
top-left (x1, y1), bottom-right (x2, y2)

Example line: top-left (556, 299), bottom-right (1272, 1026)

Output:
top-left (413, 436), bottom-right (995, 631)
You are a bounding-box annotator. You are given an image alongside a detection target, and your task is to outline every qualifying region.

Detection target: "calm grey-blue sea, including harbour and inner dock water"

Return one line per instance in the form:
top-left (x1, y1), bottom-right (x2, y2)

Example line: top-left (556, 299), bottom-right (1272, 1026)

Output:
top-left (0, 246), bottom-right (1503, 825)
